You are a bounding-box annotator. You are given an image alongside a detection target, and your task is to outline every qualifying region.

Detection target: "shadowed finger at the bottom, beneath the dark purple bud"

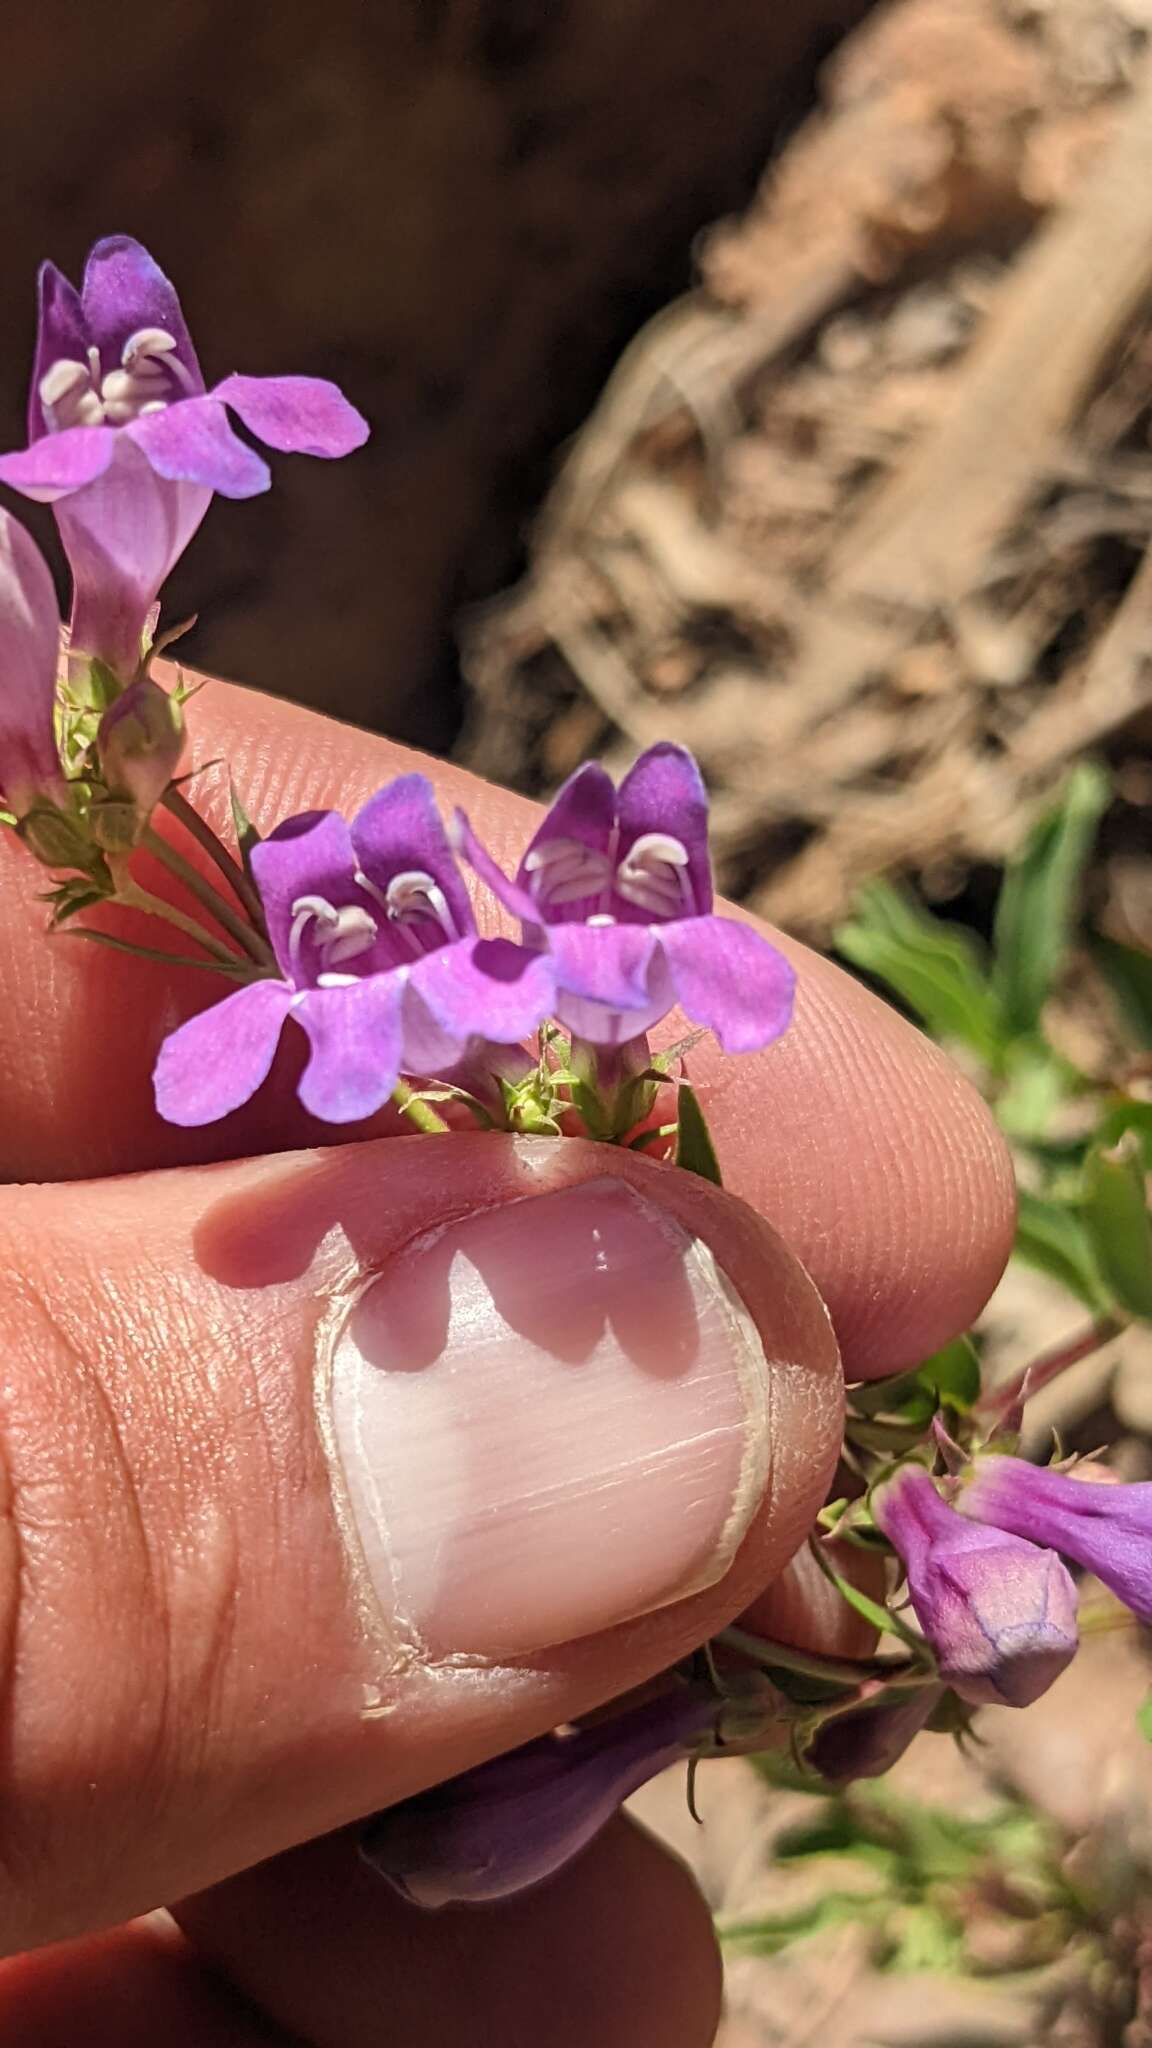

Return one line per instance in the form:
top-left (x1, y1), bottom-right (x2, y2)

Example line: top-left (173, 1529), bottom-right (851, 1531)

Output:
top-left (178, 1819), bottom-right (722, 2048)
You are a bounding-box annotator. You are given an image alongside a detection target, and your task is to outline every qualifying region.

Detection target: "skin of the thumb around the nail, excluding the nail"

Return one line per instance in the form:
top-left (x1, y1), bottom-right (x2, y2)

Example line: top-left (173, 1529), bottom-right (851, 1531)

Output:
top-left (0, 1137), bottom-right (840, 1950)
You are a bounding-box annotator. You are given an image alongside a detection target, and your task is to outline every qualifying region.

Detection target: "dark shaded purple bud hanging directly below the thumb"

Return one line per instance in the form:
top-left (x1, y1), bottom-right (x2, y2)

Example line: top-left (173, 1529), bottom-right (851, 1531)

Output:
top-left (361, 1686), bottom-right (722, 1907)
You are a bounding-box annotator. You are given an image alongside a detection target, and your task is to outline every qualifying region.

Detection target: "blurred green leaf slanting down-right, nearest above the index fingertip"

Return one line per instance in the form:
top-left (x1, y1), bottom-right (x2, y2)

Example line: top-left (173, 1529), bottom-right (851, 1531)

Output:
top-left (834, 883), bottom-right (1004, 1067)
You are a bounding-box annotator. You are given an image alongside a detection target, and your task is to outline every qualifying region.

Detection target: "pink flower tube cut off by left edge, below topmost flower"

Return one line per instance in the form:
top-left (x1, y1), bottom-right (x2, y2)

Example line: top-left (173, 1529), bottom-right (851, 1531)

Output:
top-left (0, 510), bottom-right (64, 817)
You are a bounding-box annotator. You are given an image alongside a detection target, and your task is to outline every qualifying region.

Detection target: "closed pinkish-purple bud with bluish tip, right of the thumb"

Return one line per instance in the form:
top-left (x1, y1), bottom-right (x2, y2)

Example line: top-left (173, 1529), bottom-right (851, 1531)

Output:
top-left (873, 1464), bottom-right (1076, 1706)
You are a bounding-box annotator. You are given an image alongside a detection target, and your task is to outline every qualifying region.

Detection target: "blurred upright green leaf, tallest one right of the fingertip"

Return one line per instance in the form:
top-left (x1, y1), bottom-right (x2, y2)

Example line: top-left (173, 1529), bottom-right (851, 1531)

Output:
top-left (992, 762), bottom-right (1109, 1036)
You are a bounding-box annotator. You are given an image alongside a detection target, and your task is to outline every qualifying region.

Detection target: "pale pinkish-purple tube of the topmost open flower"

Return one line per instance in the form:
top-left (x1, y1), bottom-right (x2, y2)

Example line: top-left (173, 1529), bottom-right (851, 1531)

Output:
top-left (56, 440), bottom-right (211, 680)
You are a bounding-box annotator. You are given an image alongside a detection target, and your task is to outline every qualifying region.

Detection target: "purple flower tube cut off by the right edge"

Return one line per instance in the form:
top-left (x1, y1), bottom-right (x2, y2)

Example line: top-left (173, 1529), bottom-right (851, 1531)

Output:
top-left (957, 1452), bottom-right (1152, 1622)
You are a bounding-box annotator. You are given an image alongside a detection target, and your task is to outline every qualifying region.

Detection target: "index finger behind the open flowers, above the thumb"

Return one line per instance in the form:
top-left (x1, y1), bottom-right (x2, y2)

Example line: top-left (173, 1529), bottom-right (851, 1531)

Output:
top-left (0, 684), bottom-right (1013, 1376)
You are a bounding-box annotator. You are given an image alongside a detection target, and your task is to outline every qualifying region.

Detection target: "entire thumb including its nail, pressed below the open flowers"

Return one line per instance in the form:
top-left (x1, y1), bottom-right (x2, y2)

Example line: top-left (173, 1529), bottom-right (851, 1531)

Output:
top-left (0, 1137), bottom-right (840, 1950)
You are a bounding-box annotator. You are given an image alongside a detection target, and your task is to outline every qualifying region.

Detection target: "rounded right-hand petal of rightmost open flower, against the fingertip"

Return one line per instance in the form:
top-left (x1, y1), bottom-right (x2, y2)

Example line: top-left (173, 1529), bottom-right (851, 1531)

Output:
top-left (656, 918), bottom-right (795, 1053)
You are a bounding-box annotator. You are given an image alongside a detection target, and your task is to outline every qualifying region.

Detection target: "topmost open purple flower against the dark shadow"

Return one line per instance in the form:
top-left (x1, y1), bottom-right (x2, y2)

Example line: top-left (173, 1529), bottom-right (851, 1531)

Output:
top-left (0, 236), bottom-right (367, 680)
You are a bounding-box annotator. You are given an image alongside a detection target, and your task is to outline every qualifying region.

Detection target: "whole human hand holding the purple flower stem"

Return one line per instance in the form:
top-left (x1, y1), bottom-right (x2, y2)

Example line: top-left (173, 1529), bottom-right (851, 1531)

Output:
top-left (0, 684), bottom-right (1011, 2048)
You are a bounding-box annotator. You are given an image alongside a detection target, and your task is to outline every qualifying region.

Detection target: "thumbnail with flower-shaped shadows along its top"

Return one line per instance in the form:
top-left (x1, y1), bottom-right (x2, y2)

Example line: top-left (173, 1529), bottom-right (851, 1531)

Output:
top-left (328, 1180), bottom-right (769, 1661)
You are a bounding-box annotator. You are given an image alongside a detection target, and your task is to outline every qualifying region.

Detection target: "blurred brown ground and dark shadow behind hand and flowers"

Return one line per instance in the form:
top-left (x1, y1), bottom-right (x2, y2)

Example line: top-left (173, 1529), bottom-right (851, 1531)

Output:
top-left (0, 0), bottom-right (1152, 2048)
